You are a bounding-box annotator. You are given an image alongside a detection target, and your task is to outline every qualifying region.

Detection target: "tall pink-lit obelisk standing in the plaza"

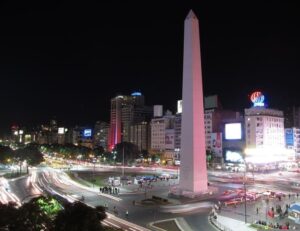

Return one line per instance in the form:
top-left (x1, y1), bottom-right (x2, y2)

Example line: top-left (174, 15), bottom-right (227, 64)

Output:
top-left (179, 10), bottom-right (208, 193)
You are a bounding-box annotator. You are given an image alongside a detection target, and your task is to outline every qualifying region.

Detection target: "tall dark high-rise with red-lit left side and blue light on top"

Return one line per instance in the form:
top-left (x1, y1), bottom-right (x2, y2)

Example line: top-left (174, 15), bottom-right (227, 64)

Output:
top-left (108, 92), bottom-right (153, 150)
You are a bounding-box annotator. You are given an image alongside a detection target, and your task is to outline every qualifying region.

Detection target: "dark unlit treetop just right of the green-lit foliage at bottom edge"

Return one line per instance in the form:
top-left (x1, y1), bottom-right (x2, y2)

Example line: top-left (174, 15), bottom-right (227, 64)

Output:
top-left (54, 202), bottom-right (106, 231)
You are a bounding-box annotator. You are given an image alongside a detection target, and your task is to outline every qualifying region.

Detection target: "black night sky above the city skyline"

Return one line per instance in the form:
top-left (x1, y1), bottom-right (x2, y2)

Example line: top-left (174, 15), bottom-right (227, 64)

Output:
top-left (0, 0), bottom-right (300, 133)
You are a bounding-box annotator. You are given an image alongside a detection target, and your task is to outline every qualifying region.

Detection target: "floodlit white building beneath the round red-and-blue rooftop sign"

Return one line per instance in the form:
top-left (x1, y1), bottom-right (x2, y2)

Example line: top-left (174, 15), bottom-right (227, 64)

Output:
top-left (245, 107), bottom-right (287, 163)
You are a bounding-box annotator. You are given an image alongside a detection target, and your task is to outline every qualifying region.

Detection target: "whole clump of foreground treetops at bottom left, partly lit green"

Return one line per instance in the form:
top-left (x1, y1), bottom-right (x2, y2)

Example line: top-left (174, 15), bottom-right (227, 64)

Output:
top-left (0, 196), bottom-right (113, 231)
